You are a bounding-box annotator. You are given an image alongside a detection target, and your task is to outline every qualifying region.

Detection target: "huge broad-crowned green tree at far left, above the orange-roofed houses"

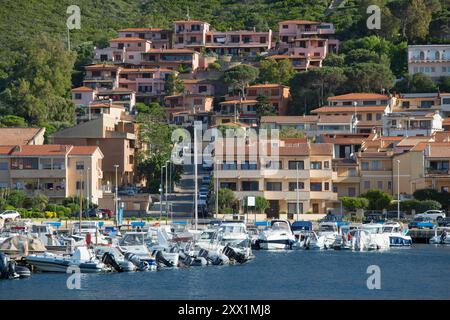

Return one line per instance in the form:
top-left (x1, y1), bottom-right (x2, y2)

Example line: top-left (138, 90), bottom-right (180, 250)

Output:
top-left (1, 35), bottom-right (75, 125)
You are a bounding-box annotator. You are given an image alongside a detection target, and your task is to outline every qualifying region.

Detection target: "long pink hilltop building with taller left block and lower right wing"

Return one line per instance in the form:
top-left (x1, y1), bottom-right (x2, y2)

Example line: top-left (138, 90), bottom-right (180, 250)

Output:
top-left (174, 20), bottom-right (272, 56)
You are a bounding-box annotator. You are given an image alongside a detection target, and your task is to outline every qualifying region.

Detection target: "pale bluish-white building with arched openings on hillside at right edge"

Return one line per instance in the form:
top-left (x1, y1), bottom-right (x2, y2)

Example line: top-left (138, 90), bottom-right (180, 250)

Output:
top-left (408, 44), bottom-right (450, 80)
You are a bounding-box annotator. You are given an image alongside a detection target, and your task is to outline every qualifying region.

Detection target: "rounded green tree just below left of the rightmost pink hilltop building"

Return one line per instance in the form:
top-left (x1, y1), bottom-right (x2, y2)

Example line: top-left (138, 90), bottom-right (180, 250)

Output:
top-left (258, 57), bottom-right (296, 85)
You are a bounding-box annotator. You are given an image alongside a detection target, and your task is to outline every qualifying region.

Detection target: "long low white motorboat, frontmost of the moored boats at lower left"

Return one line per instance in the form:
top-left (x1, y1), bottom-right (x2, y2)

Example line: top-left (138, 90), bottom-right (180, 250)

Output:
top-left (25, 246), bottom-right (107, 273)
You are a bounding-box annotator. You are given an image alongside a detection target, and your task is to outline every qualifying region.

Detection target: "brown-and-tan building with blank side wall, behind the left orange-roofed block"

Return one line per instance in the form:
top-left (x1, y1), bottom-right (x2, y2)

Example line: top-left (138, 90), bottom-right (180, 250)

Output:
top-left (51, 114), bottom-right (144, 190)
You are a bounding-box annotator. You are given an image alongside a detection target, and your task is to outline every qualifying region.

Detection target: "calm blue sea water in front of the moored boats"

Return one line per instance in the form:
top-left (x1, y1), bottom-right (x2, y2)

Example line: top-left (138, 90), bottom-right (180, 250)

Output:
top-left (0, 245), bottom-right (450, 300)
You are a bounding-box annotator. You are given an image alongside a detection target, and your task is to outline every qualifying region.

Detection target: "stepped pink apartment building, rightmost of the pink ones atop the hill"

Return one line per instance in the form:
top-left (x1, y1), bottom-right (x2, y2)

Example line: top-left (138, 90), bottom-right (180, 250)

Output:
top-left (272, 20), bottom-right (339, 71)
